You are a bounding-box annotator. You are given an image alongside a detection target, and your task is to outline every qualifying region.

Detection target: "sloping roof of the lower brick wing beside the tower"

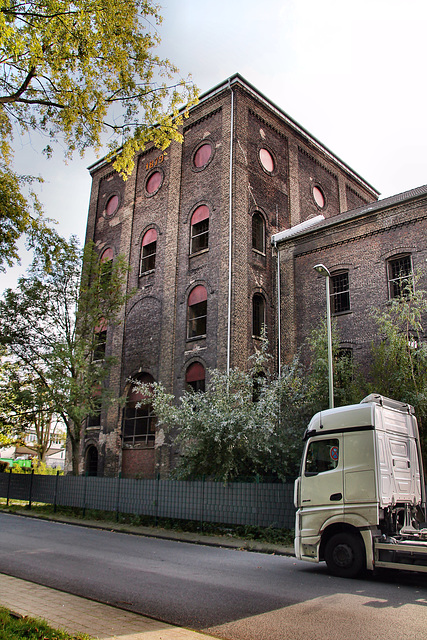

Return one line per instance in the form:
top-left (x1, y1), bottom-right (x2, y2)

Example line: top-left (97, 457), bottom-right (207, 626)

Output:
top-left (271, 185), bottom-right (427, 245)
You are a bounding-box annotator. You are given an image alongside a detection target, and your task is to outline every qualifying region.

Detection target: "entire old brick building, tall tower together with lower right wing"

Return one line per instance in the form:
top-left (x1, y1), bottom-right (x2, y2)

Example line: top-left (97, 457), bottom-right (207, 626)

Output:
top-left (82, 75), bottom-right (427, 477)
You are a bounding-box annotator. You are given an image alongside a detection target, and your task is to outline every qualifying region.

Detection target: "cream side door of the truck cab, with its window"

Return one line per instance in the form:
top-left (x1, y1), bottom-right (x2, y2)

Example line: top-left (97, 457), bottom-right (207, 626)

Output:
top-left (299, 435), bottom-right (344, 537)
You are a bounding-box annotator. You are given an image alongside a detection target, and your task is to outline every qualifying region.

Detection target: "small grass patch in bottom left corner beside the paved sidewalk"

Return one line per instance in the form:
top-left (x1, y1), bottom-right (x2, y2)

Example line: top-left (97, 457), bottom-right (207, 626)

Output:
top-left (0, 607), bottom-right (90, 640)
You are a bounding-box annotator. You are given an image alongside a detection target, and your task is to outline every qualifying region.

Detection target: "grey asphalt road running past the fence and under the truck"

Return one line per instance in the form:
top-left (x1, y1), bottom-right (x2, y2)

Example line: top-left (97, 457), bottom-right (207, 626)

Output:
top-left (0, 514), bottom-right (427, 640)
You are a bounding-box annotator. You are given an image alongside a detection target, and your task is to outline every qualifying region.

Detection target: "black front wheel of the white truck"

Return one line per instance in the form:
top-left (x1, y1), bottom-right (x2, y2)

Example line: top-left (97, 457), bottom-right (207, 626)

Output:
top-left (325, 533), bottom-right (365, 578)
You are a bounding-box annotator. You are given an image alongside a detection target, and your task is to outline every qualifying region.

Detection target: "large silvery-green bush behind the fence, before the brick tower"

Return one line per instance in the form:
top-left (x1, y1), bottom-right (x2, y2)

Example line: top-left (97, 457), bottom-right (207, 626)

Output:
top-left (135, 340), bottom-right (313, 482)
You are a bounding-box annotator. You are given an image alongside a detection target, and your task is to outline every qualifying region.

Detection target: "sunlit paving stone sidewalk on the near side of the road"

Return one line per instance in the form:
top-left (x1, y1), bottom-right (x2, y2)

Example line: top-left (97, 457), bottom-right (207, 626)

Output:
top-left (0, 573), bottom-right (219, 640)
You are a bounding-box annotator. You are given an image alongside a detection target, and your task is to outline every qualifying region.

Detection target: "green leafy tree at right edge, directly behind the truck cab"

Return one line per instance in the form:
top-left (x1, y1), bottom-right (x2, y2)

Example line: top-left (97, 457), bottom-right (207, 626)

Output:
top-left (370, 278), bottom-right (427, 457)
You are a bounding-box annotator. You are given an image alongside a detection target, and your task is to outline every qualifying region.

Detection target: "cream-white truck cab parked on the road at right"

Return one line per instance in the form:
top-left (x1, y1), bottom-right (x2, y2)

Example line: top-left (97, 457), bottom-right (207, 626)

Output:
top-left (295, 394), bottom-right (427, 577)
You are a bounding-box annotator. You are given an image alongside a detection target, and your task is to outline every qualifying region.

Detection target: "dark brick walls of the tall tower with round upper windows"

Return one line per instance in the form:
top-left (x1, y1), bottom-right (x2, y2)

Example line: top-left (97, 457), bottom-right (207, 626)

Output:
top-left (78, 75), bottom-right (378, 477)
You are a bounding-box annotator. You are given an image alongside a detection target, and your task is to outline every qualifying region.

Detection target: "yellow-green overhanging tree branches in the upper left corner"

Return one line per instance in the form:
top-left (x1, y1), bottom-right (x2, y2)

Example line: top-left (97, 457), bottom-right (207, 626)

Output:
top-left (0, 0), bottom-right (197, 266)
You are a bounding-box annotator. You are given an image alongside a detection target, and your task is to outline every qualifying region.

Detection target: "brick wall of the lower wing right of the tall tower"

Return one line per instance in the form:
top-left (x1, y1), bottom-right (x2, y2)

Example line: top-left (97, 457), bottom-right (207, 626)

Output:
top-left (278, 187), bottom-right (427, 366)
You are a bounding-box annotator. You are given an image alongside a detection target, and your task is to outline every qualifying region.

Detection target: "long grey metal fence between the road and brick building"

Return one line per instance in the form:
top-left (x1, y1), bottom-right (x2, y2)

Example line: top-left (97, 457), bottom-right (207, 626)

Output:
top-left (0, 473), bottom-right (295, 529)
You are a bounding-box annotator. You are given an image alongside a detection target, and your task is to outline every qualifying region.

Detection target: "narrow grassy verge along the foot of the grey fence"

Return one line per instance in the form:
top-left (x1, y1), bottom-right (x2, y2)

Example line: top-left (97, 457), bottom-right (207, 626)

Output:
top-left (0, 498), bottom-right (294, 548)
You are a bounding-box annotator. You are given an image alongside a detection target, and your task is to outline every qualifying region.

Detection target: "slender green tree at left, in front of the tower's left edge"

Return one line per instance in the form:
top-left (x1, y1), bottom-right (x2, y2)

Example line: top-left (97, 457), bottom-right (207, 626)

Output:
top-left (0, 238), bottom-right (128, 474)
